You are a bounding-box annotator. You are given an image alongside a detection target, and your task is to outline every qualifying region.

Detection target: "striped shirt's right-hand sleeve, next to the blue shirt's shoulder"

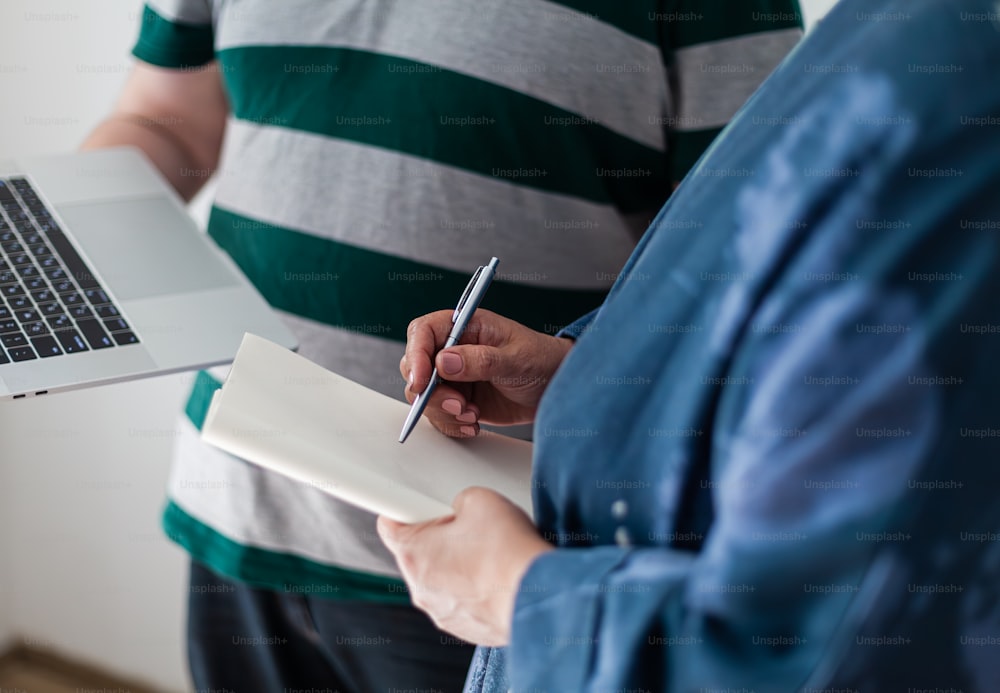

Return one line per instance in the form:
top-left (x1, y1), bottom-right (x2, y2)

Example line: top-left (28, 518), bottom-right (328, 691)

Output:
top-left (660, 0), bottom-right (802, 181)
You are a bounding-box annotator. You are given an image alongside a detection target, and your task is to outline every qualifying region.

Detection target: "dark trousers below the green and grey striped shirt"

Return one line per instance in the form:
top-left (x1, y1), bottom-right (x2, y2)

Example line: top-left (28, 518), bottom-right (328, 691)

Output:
top-left (188, 562), bottom-right (473, 693)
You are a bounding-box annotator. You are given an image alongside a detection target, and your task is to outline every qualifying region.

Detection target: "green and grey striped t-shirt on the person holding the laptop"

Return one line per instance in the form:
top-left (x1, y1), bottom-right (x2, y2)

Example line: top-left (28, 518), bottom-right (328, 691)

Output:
top-left (134, 0), bottom-right (801, 601)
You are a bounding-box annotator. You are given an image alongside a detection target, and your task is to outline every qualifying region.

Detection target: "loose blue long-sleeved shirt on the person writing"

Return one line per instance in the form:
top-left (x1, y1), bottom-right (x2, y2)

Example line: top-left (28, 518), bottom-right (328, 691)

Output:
top-left (468, 0), bottom-right (1000, 693)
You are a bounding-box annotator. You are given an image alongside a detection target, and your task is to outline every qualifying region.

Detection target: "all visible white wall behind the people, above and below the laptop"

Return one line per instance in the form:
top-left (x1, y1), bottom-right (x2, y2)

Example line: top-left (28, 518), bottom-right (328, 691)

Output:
top-left (0, 0), bottom-right (835, 690)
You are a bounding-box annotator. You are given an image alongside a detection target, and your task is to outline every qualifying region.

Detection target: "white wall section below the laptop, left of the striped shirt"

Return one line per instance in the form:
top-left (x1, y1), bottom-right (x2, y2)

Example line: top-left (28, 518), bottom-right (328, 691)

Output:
top-left (0, 377), bottom-right (188, 690)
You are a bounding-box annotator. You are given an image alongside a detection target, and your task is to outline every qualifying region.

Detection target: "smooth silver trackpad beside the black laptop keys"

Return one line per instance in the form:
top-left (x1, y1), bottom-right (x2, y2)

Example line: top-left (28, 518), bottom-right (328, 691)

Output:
top-left (56, 198), bottom-right (239, 300)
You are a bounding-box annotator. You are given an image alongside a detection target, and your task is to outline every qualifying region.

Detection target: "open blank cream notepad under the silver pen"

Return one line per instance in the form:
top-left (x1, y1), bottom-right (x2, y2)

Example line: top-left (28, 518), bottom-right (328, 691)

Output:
top-left (201, 334), bottom-right (532, 522)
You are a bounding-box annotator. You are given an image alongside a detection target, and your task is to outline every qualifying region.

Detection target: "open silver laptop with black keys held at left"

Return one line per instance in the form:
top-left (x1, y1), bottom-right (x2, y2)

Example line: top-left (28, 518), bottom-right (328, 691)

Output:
top-left (0, 148), bottom-right (296, 399)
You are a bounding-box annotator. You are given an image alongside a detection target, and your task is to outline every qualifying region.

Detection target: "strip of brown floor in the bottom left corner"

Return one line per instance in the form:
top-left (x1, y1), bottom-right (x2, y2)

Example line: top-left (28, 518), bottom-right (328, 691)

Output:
top-left (0, 648), bottom-right (162, 693)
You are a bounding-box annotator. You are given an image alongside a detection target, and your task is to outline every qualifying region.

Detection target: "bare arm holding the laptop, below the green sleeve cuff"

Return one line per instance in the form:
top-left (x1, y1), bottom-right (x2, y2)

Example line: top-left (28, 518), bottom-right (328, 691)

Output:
top-left (82, 63), bottom-right (229, 200)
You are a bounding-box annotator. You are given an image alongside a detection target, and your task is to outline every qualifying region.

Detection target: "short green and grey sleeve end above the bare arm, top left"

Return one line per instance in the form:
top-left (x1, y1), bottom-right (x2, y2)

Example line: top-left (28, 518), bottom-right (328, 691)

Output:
top-left (132, 0), bottom-right (215, 69)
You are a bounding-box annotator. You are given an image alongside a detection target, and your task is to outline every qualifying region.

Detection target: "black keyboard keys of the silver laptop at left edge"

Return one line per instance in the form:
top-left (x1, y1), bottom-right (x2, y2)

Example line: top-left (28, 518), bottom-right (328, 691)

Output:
top-left (0, 178), bottom-right (139, 365)
